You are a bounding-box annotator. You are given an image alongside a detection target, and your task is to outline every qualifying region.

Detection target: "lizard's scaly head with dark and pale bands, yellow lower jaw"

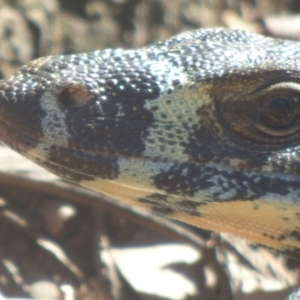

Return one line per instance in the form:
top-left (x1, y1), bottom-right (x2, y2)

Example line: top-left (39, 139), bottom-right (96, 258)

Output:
top-left (0, 28), bottom-right (300, 264)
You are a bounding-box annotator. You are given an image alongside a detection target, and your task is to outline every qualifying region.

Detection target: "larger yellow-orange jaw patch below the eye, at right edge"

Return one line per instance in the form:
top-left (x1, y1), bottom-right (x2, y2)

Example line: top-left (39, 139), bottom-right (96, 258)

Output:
top-left (172, 200), bottom-right (300, 251)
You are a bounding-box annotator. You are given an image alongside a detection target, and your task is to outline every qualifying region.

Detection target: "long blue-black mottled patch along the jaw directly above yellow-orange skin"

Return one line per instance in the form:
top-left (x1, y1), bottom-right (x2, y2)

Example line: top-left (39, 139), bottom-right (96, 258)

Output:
top-left (153, 163), bottom-right (300, 202)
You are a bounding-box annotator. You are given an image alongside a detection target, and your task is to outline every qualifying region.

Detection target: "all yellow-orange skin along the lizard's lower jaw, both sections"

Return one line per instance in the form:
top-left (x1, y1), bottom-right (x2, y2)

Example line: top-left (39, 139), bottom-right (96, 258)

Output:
top-left (81, 179), bottom-right (300, 251)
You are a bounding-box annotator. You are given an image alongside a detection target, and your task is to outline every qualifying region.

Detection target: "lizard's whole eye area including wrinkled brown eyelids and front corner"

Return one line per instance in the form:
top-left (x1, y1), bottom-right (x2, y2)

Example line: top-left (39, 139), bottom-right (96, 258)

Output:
top-left (220, 82), bottom-right (300, 145)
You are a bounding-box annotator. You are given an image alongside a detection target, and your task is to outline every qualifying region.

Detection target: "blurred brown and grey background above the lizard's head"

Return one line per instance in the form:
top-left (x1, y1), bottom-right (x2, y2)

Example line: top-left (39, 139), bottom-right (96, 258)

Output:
top-left (0, 0), bottom-right (300, 77)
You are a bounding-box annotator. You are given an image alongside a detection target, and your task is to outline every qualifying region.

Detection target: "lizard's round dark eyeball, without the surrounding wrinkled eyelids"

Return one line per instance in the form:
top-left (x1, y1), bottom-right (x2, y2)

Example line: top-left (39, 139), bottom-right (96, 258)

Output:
top-left (260, 92), bottom-right (299, 129)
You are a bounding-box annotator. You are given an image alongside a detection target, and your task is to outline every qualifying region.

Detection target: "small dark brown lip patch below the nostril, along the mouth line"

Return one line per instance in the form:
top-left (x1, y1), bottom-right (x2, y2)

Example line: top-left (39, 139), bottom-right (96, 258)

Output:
top-left (48, 146), bottom-right (119, 181)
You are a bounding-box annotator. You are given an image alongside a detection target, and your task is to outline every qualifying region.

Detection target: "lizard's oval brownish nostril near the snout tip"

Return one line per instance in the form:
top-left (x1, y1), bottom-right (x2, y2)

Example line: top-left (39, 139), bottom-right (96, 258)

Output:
top-left (58, 86), bottom-right (90, 108)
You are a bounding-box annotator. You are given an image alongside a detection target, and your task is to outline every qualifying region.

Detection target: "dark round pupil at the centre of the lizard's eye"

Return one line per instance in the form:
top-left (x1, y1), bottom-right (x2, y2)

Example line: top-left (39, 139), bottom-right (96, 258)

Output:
top-left (269, 97), bottom-right (294, 121)
